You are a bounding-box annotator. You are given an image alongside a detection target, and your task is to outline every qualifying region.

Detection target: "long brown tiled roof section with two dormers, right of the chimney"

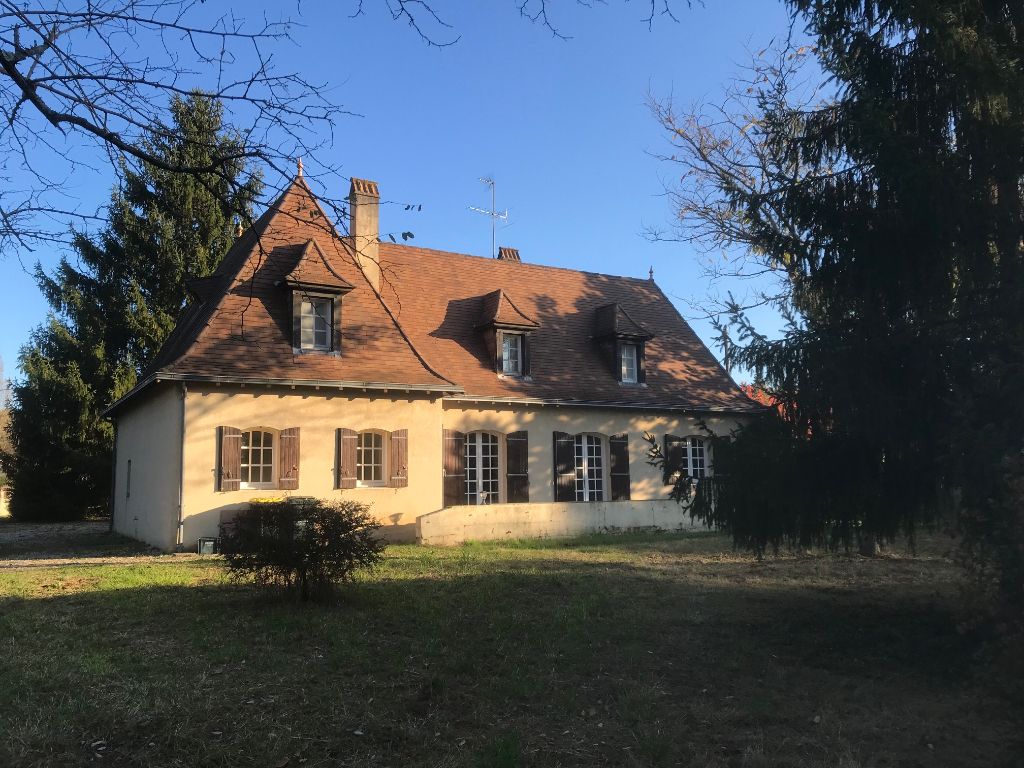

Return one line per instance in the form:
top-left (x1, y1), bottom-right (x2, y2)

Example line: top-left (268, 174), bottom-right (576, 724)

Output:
top-left (381, 243), bottom-right (759, 411)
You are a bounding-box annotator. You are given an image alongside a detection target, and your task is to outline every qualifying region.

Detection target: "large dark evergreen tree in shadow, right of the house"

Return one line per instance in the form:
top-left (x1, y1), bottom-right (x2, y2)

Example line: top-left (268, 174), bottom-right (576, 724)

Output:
top-left (655, 0), bottom-right (1024, 622)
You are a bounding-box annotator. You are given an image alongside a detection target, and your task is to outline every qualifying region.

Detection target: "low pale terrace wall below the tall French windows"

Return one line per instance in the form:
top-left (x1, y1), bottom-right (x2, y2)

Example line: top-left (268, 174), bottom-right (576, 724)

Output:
top-left (418, 499), bottom-right (697, 546)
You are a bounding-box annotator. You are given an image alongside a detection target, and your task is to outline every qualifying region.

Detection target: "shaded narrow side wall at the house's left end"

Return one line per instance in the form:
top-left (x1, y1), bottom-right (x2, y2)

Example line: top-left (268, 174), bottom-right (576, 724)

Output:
top-left (113, 382), bottom-right (181, 550)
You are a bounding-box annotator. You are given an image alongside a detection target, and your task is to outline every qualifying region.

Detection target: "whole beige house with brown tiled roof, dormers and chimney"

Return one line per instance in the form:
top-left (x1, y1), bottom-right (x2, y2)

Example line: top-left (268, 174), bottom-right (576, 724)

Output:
top-left (109, 170), bottom-right (760, 550)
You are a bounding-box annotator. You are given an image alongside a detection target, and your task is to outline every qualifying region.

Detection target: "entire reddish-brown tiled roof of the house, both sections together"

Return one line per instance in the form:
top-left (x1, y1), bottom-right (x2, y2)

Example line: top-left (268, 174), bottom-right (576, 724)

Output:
top-left (128, 177), bottom-right (759, 412)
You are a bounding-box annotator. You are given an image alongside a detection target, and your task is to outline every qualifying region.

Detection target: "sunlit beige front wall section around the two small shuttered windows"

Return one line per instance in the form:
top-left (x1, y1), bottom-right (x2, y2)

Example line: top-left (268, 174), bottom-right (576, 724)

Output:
top-left (182, 387), bottom-right (441, 548)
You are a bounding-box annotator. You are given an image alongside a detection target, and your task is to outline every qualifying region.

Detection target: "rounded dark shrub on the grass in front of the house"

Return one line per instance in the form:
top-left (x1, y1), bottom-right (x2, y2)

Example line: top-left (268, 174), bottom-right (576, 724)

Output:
top-left (221, 499), bottom-right (385, 600)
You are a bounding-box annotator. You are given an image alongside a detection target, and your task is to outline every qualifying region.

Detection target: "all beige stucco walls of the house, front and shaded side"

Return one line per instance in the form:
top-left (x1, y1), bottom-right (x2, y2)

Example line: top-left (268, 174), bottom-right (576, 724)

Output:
top-left (115, 383), bottom-right (735, 549)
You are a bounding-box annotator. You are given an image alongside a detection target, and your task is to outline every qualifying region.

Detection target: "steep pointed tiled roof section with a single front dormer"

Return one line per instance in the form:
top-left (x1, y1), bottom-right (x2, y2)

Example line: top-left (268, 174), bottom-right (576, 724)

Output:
top-left (144, 178), bottom-right (452, 388)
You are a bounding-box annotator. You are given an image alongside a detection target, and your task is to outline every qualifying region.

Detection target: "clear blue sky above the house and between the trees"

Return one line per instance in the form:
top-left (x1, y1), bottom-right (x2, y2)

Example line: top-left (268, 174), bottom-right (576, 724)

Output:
top-left (0, 0), bottom-right (788, 385)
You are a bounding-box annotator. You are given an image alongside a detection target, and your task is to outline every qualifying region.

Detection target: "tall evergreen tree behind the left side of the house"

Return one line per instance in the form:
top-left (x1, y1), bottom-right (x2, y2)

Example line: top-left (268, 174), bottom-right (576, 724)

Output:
top-left (2, 93), bottom-right (262, 519)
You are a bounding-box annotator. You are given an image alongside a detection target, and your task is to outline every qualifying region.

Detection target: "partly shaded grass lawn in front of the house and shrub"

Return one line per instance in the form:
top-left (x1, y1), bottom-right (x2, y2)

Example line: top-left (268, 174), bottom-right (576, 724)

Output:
top-left (0, 535), bottom-right (1022, 768)
